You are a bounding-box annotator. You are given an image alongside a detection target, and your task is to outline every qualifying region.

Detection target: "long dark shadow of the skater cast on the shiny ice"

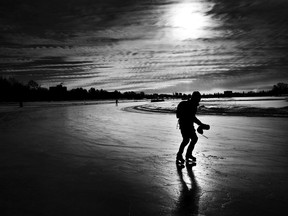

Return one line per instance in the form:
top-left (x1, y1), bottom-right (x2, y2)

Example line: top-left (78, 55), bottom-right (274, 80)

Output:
top-left (174, 165), bottom-right (201, 216)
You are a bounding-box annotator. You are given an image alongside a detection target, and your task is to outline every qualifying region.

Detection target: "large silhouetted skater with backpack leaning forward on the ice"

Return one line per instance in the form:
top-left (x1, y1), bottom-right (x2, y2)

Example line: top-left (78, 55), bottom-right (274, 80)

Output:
top-left (176, 91), bottom-right (210, 164)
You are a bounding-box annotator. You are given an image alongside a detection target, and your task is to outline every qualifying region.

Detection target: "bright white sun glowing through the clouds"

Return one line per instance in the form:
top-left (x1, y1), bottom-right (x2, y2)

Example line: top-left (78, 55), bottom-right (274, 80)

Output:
top-left (169, 3), bottom-right (209, 40)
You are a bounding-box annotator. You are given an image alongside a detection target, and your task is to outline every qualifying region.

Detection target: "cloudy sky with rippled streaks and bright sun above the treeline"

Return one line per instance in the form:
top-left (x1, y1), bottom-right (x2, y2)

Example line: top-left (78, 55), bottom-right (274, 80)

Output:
top-left (0, 0), bottom-right (288, 93)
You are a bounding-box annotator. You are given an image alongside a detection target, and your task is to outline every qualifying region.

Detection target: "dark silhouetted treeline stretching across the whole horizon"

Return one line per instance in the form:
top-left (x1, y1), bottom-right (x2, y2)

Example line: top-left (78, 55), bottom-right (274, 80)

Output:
top-left (0, 77), bottom-right (288, 104)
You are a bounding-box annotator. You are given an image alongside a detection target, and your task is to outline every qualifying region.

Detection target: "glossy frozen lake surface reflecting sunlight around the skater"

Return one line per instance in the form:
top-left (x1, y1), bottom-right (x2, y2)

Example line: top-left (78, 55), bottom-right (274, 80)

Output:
top-left (0, 102), bottom-right (288, 215)
